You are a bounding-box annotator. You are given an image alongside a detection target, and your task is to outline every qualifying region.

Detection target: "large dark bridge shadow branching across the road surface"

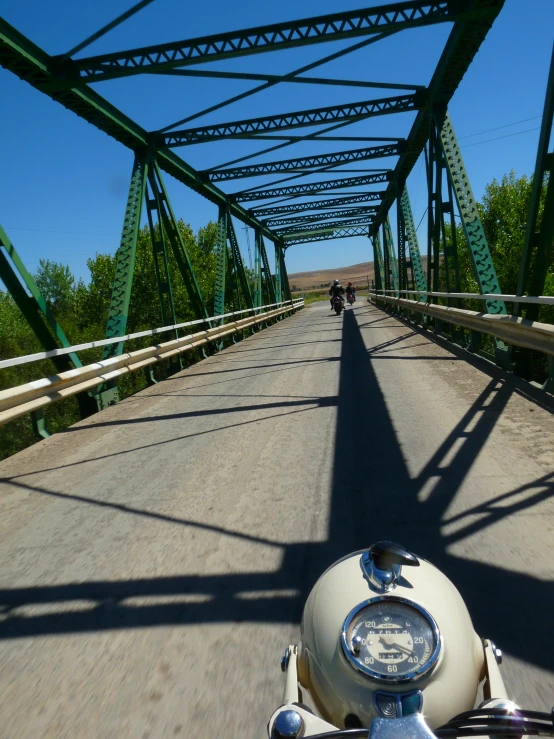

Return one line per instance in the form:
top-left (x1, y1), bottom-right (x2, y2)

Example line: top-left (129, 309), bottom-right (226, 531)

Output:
top-left (0, 311), bottom-right (554, 669)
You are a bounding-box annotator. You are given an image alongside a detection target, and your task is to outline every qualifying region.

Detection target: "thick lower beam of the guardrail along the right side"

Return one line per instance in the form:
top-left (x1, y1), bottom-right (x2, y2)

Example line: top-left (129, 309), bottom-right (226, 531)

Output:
top-left (369, 290), bottom-right (554, 355)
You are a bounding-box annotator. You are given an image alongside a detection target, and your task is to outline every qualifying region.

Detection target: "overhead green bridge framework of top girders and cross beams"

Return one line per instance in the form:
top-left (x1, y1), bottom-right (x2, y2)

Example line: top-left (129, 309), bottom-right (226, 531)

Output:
top-left (0, 0), bottom-right (503, 254)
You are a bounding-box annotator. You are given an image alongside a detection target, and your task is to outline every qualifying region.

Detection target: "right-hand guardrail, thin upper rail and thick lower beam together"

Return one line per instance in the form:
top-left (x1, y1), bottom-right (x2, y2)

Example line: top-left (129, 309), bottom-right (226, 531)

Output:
top-left (369, 290), bottom-right (554, 355)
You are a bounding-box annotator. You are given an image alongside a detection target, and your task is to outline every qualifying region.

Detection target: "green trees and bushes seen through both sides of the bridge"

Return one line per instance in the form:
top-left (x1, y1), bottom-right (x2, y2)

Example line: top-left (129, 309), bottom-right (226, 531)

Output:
top-left (0, 172), bottom-right (554, 459)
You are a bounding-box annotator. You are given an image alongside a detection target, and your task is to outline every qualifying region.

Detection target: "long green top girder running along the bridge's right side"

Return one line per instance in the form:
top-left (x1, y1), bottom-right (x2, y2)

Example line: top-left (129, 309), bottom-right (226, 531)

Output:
top-left (373, 0), bottom-right (505, 232)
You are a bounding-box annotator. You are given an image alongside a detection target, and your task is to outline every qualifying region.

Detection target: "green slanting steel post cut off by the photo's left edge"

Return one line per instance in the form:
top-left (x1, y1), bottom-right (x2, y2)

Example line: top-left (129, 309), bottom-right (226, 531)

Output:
top-left (0, 226), bottom-right (96, 424)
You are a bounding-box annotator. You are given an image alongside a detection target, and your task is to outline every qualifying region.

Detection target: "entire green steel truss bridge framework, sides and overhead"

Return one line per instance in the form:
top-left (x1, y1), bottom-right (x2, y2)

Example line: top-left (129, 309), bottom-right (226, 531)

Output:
top-left (0, 0), bottom-right (554, 424)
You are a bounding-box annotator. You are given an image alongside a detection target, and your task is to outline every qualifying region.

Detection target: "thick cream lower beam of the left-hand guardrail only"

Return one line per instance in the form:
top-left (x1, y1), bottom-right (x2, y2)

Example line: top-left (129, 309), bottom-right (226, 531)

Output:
top-left (0, 300), bottom-right (304, 425)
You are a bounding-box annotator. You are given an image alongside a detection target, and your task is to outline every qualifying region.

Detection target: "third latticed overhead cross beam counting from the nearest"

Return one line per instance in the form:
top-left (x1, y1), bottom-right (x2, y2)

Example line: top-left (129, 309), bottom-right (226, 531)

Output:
top-left (202, 142), bottom-right (403, 182)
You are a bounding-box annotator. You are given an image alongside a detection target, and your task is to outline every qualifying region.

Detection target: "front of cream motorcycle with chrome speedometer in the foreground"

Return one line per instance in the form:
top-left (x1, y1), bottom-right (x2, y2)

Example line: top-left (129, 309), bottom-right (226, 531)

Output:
top-left (267, 541), bottom-right (554, 739)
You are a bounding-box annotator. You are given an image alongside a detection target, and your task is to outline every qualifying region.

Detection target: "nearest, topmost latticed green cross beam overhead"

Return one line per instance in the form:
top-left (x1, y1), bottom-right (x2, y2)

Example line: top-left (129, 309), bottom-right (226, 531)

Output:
top-left (63, 0), bottom-right (460, 82)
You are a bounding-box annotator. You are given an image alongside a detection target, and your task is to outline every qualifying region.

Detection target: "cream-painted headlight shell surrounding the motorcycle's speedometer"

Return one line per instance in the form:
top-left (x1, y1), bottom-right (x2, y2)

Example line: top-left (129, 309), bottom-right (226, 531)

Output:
top-left (298, 550), bottom-right (484, 728)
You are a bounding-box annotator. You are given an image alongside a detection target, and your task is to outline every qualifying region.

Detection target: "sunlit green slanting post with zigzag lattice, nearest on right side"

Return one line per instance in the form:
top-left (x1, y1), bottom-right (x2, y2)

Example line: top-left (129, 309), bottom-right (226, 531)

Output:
top-left (439, 112), bottom-right (506, 314)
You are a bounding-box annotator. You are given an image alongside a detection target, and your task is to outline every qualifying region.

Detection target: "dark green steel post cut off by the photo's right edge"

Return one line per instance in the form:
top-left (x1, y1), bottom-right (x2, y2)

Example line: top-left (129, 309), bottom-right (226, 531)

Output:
top-left (514, 45), bottom-right (554, 324)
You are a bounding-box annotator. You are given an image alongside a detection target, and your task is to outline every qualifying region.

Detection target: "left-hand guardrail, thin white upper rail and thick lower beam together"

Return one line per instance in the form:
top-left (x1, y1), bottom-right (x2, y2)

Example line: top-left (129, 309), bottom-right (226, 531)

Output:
top-left (0, 298), bottom-right (304, 425)
